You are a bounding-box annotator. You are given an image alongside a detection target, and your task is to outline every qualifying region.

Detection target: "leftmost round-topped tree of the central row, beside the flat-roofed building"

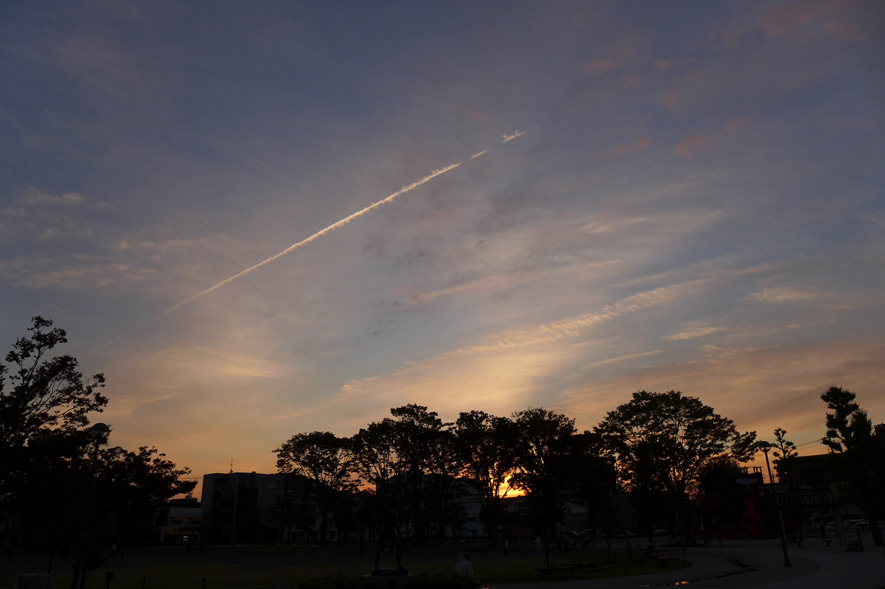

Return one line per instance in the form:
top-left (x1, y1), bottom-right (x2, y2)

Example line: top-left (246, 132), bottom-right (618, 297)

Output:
top-left (274, 432), bottom-right (358, 543)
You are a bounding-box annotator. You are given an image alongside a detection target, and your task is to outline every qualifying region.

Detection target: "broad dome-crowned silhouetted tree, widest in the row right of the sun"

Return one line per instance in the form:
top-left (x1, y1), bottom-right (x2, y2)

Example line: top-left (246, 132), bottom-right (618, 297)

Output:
top-left (594, 391), bottom-right (756, 541)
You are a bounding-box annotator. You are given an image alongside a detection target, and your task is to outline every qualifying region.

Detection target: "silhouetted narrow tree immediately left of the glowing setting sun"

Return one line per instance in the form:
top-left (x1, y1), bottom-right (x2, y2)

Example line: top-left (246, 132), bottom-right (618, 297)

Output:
top-left (454, 411), bottom-right (519, 538)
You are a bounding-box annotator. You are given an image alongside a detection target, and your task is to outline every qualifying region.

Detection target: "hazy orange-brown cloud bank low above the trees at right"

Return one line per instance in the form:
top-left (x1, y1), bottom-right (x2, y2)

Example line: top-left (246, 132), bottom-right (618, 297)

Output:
top-left (560, 339), bottom-right (885, 438)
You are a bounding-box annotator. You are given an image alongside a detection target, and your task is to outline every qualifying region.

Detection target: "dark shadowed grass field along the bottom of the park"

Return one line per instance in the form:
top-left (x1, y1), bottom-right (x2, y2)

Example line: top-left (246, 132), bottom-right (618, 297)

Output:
top-left (0, 544), bottom-right (690, 589)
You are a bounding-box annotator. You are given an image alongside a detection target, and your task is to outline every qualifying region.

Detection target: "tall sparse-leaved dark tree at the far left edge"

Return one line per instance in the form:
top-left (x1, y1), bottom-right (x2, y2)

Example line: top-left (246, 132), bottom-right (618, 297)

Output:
top-left (0, 316), bottom-right (108, 501)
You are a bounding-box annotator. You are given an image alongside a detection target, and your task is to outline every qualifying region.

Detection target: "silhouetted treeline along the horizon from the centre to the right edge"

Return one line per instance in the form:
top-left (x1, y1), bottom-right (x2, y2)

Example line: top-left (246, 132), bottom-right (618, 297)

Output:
top-left (274, 387), bottom-right (885, 544)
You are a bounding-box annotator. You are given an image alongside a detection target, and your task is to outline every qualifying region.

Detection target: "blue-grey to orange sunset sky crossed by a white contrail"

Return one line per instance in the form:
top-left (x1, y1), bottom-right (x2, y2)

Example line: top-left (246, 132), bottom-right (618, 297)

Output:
top-left (0, 0), bottom-right (885, 492)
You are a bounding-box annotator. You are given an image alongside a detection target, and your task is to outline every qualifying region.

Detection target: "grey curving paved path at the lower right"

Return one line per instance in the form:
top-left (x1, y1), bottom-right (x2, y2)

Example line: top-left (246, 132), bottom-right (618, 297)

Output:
top-left (495, 540), bottom-right (885, 589)
